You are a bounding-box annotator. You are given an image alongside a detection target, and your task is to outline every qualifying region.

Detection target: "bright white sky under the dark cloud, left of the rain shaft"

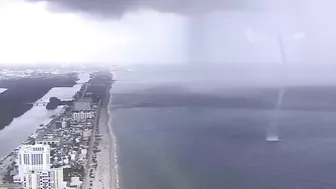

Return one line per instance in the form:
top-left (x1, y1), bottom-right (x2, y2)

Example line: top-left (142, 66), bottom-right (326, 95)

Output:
top-left (0, 1), bottom-right (188, 63)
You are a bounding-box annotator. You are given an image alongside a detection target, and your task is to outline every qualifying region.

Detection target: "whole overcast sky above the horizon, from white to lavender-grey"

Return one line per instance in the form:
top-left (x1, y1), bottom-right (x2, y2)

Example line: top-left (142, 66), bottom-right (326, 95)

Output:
top-left (0, 0), bottom-right (336, 64)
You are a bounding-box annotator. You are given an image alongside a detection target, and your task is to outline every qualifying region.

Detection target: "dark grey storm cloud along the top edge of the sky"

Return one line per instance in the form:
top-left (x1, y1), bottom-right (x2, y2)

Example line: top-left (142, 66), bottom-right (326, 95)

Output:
top-left (27, 0), bottom-right (260, 16)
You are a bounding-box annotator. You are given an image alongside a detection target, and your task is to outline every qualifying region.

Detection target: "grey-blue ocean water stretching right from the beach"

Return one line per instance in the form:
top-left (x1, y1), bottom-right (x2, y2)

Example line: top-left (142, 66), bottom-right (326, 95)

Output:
top-left (111, 65), bottom-right (336, 189)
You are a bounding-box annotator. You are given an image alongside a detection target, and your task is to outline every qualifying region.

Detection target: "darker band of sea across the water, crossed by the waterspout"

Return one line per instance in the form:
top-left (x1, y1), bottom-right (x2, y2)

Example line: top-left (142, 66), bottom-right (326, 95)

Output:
top-left (112, 86), bottom-right (336, 112)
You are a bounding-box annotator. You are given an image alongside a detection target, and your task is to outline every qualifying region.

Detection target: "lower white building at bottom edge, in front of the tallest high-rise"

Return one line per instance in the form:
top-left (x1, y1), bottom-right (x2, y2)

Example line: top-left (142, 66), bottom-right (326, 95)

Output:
top-left (22, 168), bottom-right (66, 189)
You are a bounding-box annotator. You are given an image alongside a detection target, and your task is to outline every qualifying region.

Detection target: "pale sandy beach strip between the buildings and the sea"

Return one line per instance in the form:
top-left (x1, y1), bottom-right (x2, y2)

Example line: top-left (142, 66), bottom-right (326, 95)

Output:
top-left (87, 88), bottom-right (119, 189)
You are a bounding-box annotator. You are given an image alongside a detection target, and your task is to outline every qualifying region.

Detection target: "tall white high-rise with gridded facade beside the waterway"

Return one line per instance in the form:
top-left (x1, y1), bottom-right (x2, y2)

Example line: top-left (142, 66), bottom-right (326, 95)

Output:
top-left (17, 144), bottom-right (50, 181)
